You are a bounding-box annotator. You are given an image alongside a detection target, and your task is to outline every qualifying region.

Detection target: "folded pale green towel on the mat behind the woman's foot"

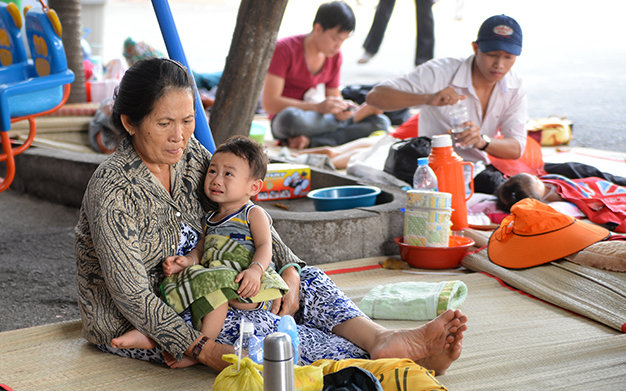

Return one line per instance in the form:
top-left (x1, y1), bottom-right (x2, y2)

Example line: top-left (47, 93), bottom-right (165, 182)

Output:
top-left (359, 281), bottom-right (467, 320)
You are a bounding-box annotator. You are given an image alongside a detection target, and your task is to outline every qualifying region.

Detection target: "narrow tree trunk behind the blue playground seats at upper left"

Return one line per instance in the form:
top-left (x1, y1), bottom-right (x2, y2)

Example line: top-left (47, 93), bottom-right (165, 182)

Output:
top-left (48, 0), bottom-right (87, 103)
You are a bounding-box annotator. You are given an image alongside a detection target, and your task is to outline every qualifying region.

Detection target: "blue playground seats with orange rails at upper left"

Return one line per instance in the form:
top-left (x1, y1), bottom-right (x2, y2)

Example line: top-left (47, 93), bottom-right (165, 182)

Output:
top-left (0, 0), bottom-right (74, 192)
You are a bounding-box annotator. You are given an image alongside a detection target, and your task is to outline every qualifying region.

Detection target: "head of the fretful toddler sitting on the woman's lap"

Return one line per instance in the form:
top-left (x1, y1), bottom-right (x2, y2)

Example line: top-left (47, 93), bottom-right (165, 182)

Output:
top-left (204, 136), bottom-right (268, 206)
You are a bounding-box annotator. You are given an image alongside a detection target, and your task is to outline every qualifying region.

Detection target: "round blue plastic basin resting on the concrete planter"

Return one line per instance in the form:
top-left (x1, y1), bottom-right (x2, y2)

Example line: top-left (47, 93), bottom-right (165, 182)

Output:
top-left (307, 186), bottom-right (380, 211)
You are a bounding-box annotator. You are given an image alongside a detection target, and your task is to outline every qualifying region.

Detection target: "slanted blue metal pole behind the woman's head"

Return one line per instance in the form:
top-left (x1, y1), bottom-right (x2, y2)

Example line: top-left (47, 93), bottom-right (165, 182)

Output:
top-left (152, 0), bottom-right (215, 153)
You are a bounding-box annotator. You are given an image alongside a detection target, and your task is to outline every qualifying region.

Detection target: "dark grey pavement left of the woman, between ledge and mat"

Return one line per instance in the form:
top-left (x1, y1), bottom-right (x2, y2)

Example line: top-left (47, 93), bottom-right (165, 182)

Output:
top-left (0, 191), bottom-right (79, 331)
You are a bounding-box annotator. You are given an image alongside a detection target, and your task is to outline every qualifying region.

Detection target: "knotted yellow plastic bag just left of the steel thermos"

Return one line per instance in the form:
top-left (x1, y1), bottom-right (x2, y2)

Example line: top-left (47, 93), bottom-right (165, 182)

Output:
top-left (213, 354), bottom-right (263, 391)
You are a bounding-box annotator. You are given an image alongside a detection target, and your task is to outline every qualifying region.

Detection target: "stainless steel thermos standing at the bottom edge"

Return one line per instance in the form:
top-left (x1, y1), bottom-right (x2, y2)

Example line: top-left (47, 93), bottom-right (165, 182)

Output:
top-left (263, 332), bottom-right (295, 391)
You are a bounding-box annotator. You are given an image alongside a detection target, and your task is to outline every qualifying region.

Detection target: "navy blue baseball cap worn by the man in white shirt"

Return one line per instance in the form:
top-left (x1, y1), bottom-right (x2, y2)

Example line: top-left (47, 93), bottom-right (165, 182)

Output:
top-left (476, 15), bottom-right (522, 56)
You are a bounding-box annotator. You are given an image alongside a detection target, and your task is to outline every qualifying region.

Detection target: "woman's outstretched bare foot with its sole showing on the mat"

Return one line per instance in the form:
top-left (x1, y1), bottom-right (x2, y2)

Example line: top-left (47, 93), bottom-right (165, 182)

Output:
top-left (369, 310), bottom-right (467, 374)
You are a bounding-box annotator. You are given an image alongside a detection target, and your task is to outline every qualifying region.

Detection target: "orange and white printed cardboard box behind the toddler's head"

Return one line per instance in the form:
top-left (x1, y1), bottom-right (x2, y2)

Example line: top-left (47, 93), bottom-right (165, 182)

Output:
top-left (254, 163), bottom-right (311, 201)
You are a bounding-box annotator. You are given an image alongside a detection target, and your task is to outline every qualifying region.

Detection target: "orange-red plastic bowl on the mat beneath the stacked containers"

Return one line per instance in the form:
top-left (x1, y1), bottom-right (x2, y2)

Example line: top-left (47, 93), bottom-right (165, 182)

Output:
top-left (393, 235), bottom-right (474, 269)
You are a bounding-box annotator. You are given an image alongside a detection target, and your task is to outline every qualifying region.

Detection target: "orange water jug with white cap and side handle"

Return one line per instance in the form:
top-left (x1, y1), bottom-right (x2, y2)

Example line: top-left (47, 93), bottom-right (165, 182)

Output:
top-left (428, 134), bottom-right (474, 231)
